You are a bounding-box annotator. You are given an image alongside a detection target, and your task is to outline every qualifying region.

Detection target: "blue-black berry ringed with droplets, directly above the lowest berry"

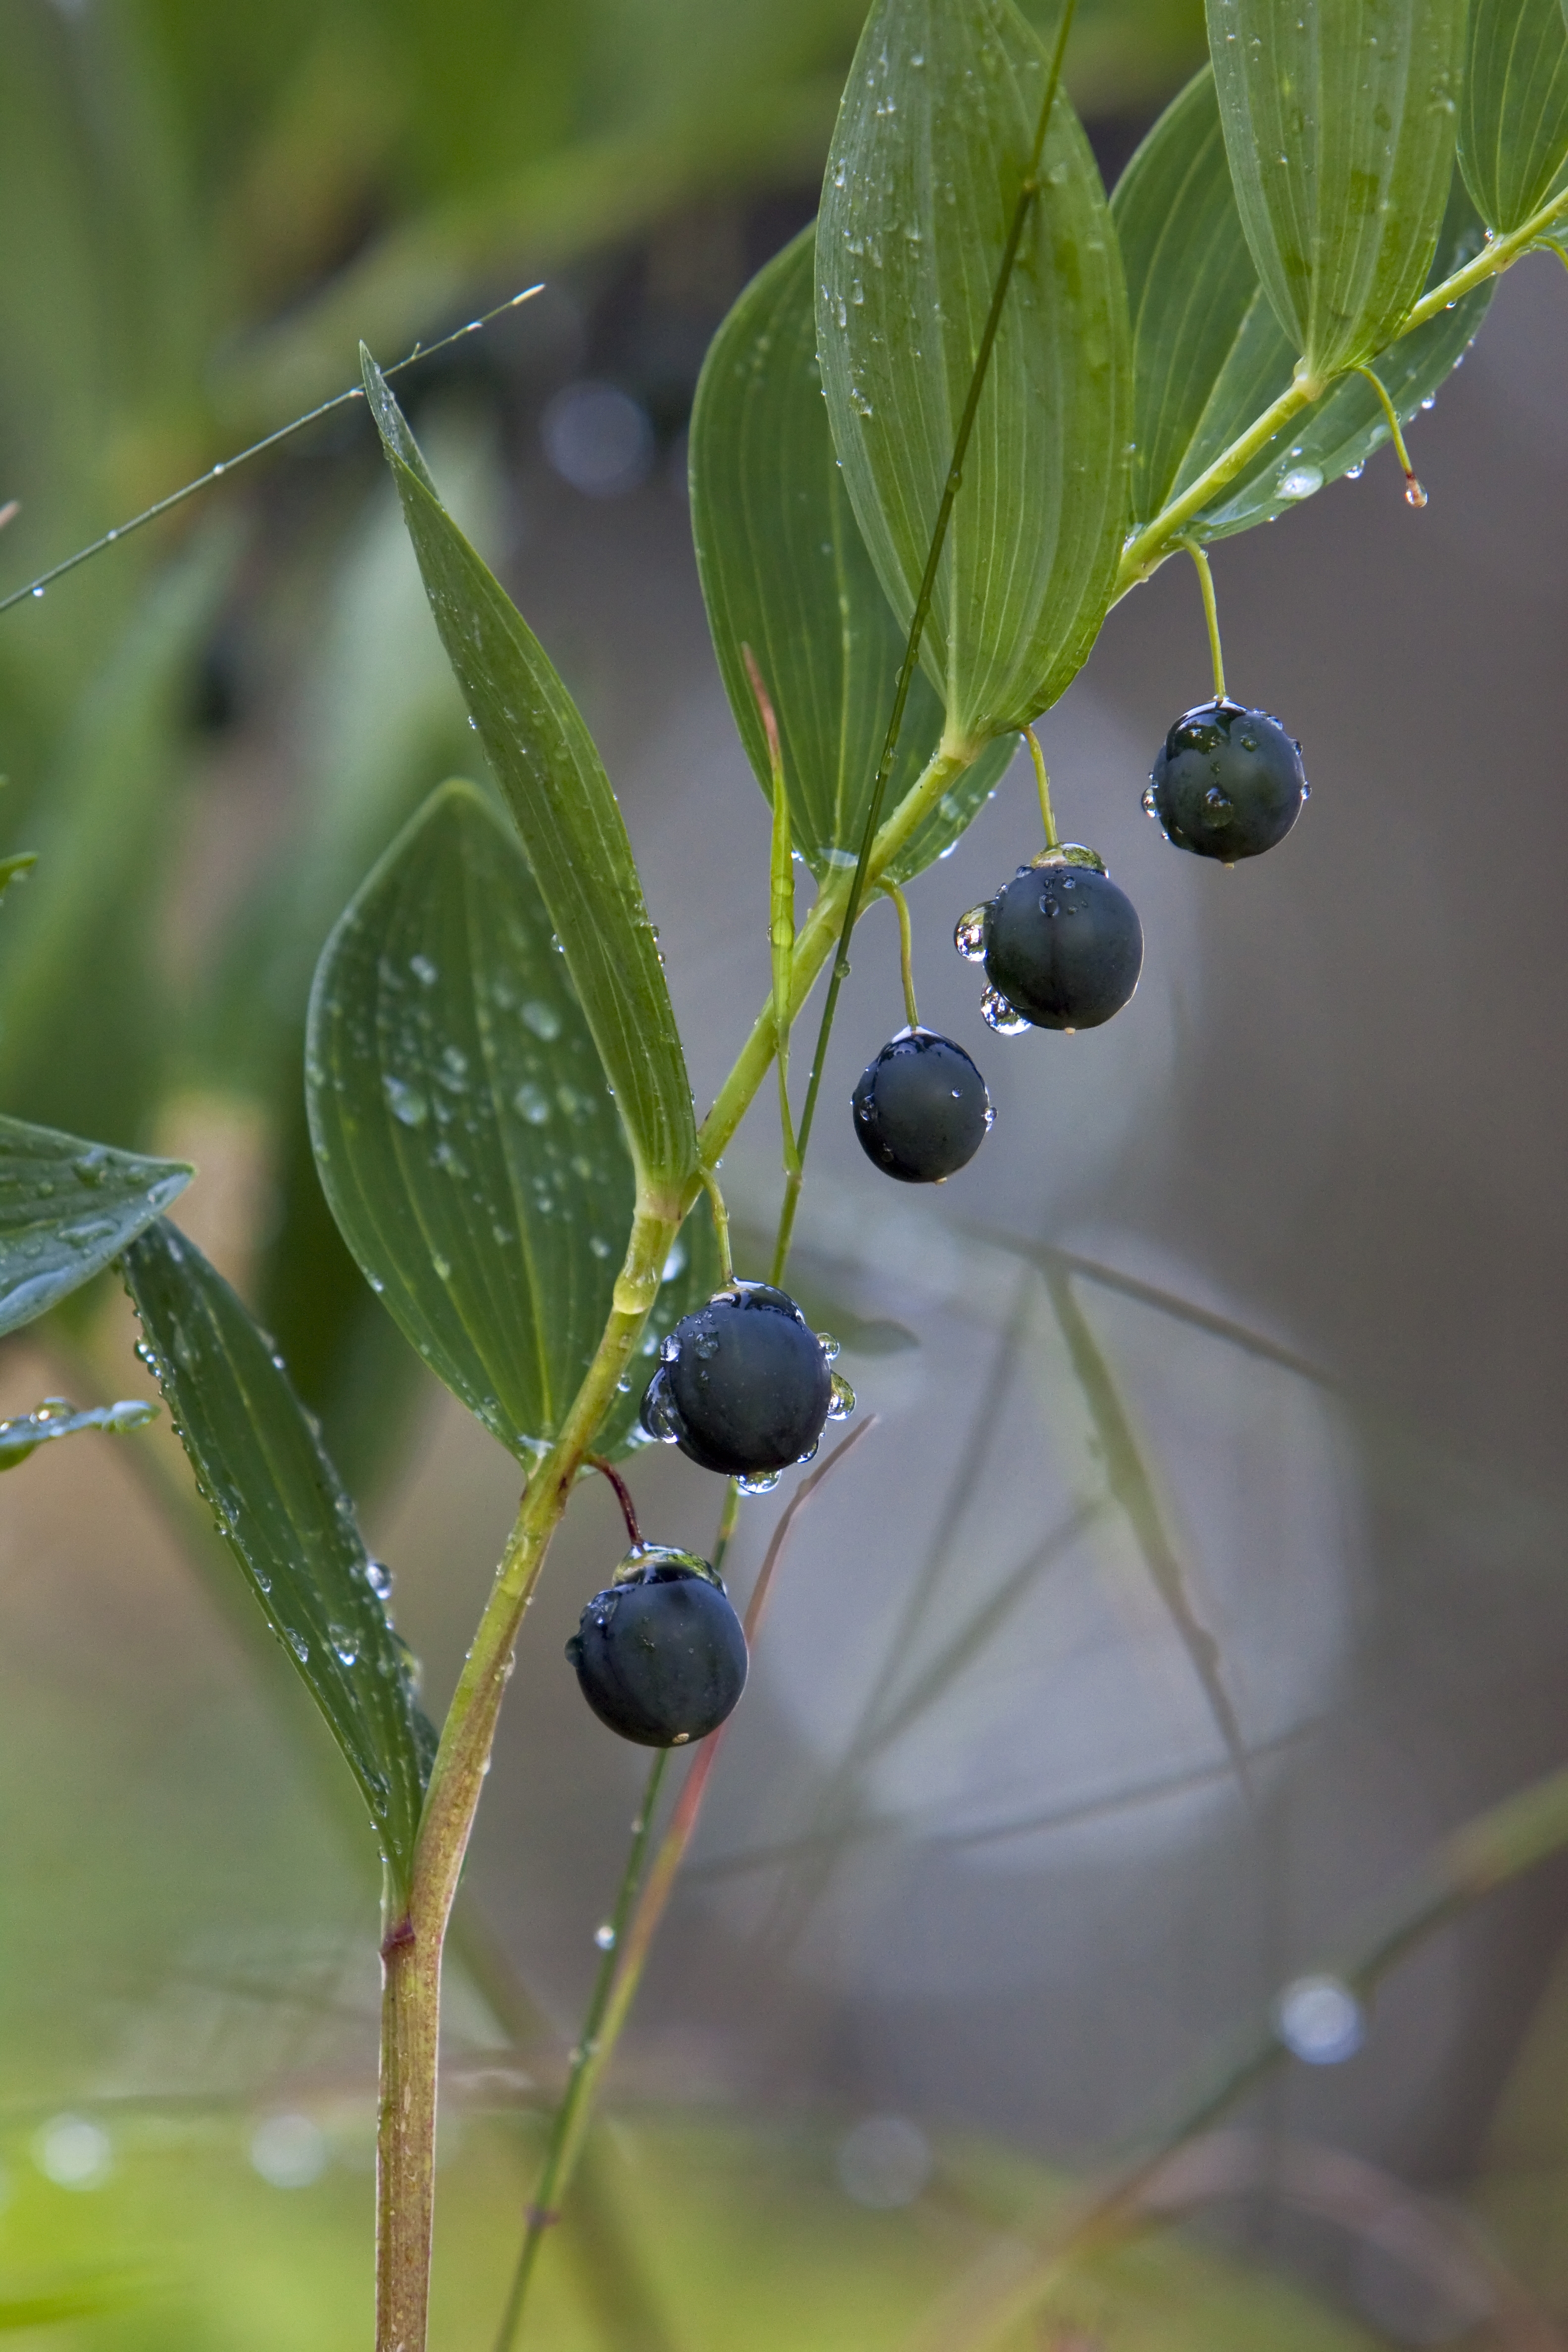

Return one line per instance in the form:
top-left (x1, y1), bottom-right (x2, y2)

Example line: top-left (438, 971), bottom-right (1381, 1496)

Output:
top-left (642, 1282), bottom-right (856, 1486)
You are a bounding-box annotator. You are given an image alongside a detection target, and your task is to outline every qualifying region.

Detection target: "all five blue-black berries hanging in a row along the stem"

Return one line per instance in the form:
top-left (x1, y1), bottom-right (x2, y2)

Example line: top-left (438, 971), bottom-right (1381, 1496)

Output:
top-left (567, 694), bottom-right (1307, 1748)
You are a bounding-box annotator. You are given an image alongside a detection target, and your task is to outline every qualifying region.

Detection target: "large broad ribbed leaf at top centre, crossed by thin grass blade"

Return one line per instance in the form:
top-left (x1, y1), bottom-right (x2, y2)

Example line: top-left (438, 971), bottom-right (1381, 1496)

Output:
top-left (816, 0), bottom-right (1131, 743)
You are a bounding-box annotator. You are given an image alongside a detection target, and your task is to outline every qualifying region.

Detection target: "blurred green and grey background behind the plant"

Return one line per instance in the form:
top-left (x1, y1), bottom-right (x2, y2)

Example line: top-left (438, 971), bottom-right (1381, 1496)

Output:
top-left (0, 0), bottom-right (1568, 2352)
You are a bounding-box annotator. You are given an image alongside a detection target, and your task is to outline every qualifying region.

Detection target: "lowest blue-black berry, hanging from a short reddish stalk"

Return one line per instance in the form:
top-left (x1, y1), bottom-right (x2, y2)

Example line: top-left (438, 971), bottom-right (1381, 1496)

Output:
top-left (567, 1543), bottom-right (745, 1748)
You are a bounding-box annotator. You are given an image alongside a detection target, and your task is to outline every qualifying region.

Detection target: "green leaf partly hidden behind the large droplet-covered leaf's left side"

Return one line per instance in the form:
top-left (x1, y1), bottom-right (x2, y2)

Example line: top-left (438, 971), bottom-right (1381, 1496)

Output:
top-left (691, 228), bottom-right (1013, 882)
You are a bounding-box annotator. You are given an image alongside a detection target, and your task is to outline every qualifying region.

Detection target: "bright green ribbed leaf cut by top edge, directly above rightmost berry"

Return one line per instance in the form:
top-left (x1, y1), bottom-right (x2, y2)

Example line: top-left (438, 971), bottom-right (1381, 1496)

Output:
top-left (1208, 0), bottom-right (1465, 379)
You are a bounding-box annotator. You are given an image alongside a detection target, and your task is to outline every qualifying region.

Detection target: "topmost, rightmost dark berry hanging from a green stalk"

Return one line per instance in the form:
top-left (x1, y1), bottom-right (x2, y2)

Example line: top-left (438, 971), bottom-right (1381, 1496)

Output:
top-left (1142, 701), bottom-right (1307, 866)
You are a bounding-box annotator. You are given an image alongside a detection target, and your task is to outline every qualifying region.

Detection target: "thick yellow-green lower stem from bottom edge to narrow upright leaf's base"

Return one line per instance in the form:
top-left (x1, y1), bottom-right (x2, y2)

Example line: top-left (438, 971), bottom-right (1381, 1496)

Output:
top-left (376, 1202), bottom-right (680, 2352)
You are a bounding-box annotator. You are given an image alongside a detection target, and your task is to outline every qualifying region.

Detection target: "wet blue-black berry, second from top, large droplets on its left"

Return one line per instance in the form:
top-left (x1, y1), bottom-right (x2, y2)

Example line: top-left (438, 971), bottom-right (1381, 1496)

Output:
top-left (985, 847), bottom-right (1142, 1030)
